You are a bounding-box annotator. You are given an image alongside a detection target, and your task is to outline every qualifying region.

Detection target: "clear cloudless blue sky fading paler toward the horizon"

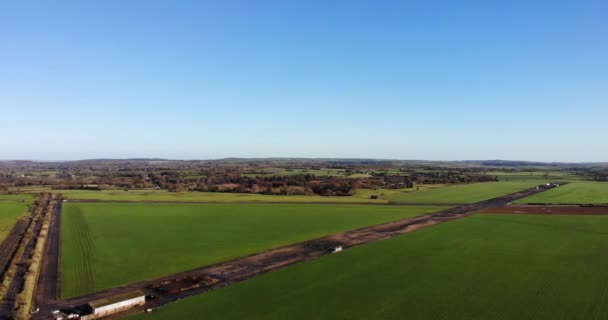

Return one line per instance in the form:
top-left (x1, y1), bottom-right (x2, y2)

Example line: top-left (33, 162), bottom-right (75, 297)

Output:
top-left (0, 0), bottom-right (608, 161)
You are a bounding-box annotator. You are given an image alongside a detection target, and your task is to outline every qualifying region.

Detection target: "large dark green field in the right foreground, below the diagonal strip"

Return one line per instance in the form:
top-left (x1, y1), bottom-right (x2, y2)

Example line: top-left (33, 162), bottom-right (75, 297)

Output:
top-left (130, 215), bottom-right (608, 320)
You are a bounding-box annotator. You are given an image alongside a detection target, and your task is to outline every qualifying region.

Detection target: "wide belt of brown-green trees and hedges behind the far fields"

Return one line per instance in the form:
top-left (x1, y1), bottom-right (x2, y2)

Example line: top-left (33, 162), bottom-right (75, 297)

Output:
top-left (0, 160), bottom-right (496, 196)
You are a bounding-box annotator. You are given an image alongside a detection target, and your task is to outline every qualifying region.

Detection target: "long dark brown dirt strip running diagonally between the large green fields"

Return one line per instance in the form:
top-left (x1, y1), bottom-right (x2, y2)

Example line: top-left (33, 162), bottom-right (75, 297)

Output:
top-left (33, 186), bottom-right (552, 319)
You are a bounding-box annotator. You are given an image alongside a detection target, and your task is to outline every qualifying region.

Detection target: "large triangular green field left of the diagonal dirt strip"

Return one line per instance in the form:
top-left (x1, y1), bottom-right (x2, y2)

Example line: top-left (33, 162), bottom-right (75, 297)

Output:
top-left (61, 203), bottom-right (443, 297)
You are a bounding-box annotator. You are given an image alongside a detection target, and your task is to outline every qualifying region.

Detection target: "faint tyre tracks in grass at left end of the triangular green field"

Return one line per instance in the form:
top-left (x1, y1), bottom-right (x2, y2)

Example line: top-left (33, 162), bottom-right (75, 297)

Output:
top-left (62, 208), bottom-right (95, 296)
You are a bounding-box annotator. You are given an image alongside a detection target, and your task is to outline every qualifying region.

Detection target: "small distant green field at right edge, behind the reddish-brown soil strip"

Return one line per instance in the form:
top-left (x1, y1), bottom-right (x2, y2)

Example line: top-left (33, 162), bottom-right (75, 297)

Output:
top-left (516, 181), bottom-right (608, 204)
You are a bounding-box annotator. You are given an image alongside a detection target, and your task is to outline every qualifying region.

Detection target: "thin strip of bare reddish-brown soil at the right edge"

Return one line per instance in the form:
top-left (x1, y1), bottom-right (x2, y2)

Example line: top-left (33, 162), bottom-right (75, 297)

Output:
top-left (483, 205), bottom-right (608, 215)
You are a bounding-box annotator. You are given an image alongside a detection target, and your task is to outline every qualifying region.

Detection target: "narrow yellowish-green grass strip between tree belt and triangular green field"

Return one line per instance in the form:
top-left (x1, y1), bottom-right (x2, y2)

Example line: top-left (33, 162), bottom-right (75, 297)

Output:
top-left (53, 190), bottom-right (387, 203)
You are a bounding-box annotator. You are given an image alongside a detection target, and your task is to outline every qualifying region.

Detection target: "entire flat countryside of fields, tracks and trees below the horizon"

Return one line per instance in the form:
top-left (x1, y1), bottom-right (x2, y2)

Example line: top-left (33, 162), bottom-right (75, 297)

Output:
top-left (0, 161), bottom-right (608, 319)
